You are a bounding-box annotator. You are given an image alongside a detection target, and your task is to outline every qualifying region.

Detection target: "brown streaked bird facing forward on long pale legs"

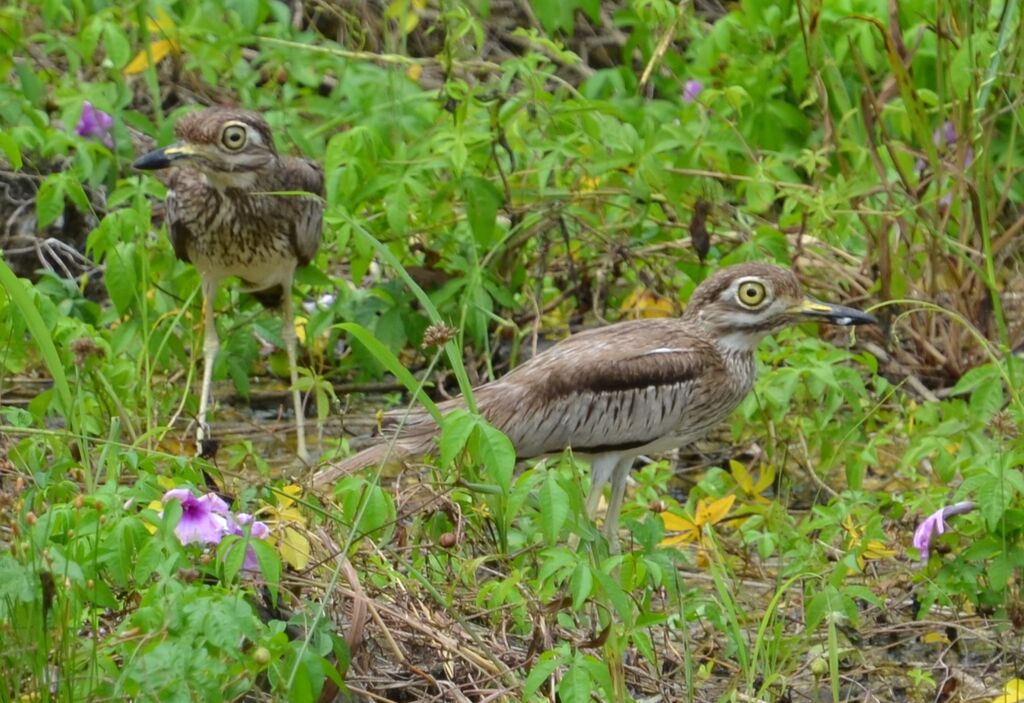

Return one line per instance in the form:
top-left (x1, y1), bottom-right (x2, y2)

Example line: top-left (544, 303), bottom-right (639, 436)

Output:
top-left (132, 107), bottom-right (324, 460)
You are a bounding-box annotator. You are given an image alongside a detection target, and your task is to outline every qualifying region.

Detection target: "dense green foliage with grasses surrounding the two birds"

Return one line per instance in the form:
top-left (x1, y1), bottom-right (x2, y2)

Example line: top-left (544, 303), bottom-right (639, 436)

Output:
top-left (0, 0), bottom-right (1024, 702)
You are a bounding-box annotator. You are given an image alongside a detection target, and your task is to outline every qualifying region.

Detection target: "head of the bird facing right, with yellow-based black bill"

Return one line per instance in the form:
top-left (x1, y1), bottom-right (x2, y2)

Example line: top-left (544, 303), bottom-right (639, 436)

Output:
top-left (684, 263), bottom-right (878, 351)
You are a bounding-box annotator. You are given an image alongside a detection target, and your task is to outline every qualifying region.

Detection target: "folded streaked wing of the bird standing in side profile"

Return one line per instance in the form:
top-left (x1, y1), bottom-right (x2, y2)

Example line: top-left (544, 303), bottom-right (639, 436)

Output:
top-left (476, 319), bottom-right (731, 456)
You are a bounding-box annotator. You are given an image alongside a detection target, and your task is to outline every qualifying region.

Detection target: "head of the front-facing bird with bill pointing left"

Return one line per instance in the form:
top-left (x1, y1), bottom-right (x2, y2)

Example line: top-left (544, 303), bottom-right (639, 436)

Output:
top-left (132, 107), bottom-right (278, 187)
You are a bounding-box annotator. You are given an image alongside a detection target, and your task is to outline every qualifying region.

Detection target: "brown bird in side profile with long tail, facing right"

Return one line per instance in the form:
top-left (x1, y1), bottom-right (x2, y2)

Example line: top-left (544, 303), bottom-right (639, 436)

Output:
top-left (312, 262), bottom-right (877, 553)
